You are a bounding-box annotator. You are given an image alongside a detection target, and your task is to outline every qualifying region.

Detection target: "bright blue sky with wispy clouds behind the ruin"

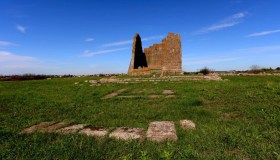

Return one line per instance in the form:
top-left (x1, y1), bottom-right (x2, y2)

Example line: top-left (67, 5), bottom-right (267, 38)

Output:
top-left (0, 0), bottom-right (280, 75)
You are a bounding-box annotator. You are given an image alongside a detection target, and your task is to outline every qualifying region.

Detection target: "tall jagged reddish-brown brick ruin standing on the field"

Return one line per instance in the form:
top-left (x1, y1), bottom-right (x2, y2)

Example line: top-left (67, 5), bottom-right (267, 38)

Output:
top-left (128, 33), bottom-right (182, 75)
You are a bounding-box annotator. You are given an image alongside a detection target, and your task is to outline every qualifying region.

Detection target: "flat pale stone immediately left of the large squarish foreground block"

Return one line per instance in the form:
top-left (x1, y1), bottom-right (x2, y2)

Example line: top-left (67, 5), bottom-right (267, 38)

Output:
top-left (109, 127), bottom-right (145, 140)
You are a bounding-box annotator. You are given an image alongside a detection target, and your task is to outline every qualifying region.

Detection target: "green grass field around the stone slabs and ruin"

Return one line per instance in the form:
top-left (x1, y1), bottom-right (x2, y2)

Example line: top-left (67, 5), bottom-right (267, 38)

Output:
top-left (0, 76), bottom-right (280, 160)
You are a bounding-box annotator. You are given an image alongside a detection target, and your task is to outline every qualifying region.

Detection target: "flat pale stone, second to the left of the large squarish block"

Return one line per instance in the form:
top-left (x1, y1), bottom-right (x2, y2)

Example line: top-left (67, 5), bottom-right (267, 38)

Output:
top-left (79, 127), bottom-right (109, 138)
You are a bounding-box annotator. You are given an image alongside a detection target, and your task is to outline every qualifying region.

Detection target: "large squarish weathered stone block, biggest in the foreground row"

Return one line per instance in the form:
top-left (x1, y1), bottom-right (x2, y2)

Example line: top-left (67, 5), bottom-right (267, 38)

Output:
top-left (147, 121), bottom-right (178, 142)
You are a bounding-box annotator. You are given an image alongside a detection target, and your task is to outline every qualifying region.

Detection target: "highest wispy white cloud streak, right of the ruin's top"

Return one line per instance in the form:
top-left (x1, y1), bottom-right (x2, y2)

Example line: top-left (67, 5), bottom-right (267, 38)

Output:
top-left (195, 12), bottom-right (248, 34)
